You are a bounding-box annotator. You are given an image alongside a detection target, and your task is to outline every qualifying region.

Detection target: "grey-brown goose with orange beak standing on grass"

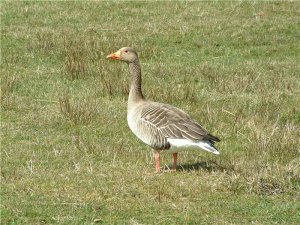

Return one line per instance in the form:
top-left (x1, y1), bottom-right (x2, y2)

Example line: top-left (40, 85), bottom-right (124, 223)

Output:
top-left (107, 47), bottom-right (220, 173)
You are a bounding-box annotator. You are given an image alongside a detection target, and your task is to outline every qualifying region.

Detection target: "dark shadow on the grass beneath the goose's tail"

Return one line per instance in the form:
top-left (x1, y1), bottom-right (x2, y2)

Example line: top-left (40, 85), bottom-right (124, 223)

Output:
top-left (170, 161), bottom-right (233, 172)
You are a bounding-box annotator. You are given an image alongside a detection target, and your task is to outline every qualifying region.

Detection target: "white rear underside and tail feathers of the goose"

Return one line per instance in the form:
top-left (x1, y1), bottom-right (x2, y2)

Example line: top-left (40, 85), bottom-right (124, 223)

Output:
top-left (168, 139), bottom-right (220, 155)
